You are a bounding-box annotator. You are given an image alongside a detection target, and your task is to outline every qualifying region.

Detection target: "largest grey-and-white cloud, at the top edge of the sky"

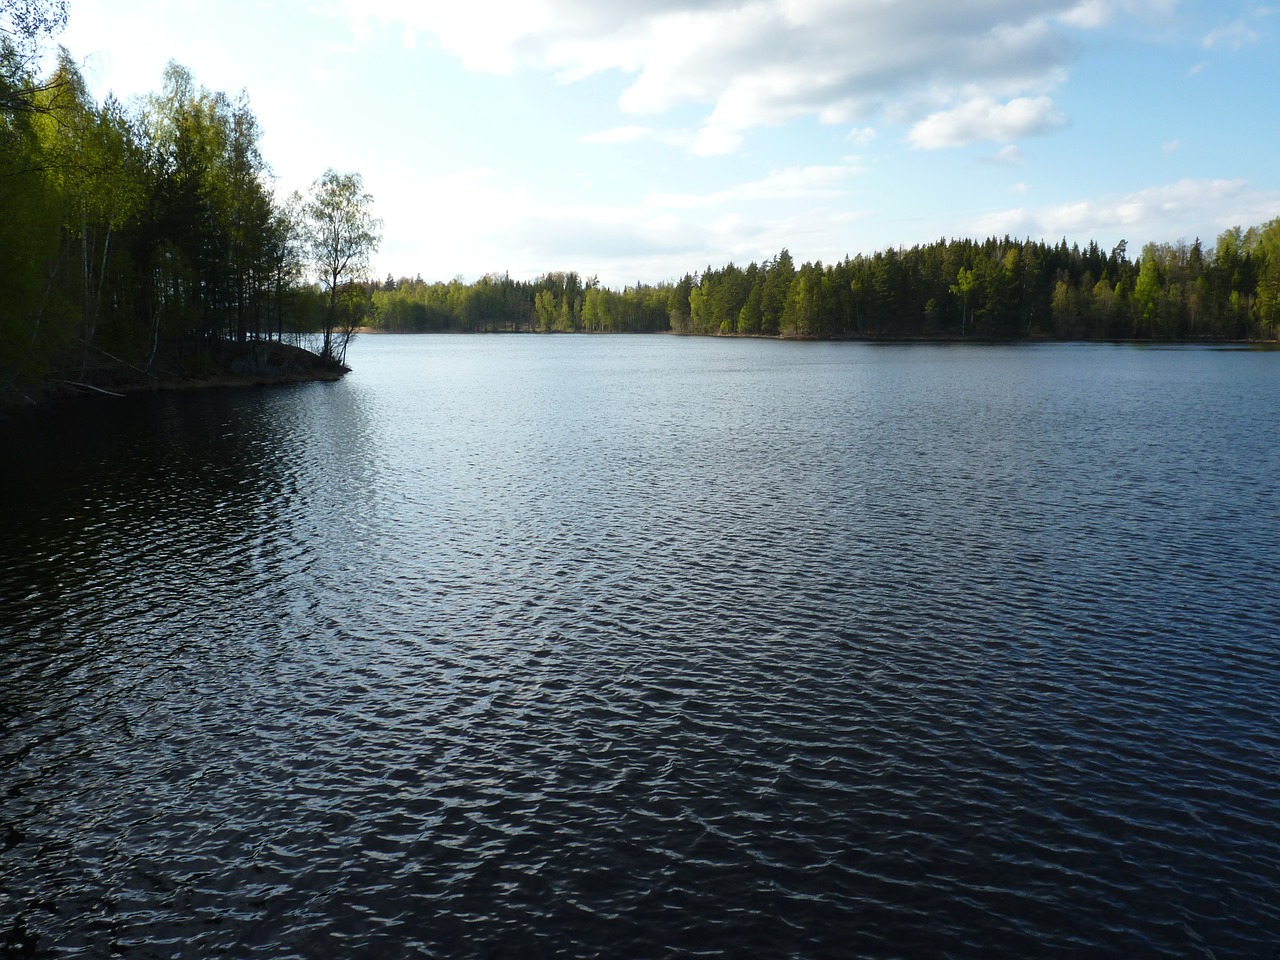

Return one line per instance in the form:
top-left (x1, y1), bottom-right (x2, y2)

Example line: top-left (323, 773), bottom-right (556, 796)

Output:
top-left (335, 0), bottom-right (1175, 155)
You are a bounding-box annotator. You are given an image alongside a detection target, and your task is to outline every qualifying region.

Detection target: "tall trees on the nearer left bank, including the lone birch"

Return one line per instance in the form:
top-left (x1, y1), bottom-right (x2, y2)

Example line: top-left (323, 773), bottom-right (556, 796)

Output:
top-left (0, 0), bottom-right (378, 393)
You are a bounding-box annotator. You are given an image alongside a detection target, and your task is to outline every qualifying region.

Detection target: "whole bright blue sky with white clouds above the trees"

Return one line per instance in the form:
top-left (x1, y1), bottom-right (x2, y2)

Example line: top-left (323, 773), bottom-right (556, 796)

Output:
top-left (45, 0), bottom-right (1280, 288)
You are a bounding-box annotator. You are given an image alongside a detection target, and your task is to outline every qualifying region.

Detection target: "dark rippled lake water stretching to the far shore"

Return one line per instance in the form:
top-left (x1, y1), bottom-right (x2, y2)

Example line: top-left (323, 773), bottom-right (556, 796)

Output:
top-left (0, 337), bottom-right (1280, 960)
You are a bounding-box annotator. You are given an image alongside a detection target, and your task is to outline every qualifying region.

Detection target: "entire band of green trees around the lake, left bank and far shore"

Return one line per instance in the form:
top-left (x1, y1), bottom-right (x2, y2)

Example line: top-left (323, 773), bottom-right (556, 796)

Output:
top-left (0, 0), bottom-right (1280, 404)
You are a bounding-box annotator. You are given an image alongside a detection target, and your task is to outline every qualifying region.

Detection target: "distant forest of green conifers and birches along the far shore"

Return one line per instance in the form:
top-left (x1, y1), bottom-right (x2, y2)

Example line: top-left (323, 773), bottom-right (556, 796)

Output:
top-left (372, 225), bottom-right (1280, 340)
